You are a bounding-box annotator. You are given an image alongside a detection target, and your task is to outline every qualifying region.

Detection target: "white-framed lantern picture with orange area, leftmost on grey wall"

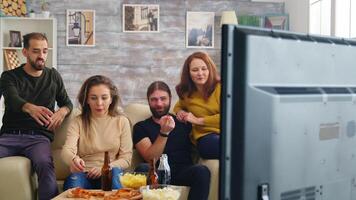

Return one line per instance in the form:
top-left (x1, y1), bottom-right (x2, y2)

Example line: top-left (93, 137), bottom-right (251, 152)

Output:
top-left (66, 10), bottom-right (95, 46)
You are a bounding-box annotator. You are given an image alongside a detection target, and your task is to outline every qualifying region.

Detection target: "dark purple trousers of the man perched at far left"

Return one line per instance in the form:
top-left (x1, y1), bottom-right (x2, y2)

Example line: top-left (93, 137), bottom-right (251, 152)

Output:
top-left (0, 131), bottom-right (58, 200)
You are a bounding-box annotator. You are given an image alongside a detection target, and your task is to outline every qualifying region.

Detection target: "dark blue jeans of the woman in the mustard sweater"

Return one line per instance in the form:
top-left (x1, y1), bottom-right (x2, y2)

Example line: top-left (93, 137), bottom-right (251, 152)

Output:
top-left (197, 133), bottom-right (220, 159)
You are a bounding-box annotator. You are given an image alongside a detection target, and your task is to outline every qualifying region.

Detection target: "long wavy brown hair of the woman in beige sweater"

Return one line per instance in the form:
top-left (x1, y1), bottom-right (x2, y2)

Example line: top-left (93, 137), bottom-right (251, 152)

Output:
top-left (78, 75), bottom-right (121, 138)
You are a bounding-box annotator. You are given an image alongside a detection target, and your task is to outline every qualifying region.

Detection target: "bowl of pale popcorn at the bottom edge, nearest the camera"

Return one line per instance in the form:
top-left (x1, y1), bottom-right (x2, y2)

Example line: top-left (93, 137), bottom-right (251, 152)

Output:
top-left (140, 184), bottom-right (181, 200)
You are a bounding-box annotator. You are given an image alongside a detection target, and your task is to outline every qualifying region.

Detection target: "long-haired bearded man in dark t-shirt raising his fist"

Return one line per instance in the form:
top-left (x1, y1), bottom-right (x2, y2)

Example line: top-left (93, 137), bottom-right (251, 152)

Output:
top-left (133, 81), bottom-right (210, 200)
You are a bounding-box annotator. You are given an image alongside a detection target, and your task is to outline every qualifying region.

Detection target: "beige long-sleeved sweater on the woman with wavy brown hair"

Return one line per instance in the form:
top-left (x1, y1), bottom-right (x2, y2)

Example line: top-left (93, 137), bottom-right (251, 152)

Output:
top-left (62, 116), bottom-right (132, 171)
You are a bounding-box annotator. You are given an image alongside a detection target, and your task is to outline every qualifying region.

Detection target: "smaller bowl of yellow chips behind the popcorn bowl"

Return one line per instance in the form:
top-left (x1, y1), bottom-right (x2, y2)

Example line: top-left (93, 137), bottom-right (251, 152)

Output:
top-left (119, 172), bottom-right (147, 189)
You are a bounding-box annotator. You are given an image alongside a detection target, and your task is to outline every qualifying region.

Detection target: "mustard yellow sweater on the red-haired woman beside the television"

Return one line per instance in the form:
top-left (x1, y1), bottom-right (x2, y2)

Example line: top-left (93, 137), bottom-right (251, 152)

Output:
top-left (173, 83), bottom-right (221, 144)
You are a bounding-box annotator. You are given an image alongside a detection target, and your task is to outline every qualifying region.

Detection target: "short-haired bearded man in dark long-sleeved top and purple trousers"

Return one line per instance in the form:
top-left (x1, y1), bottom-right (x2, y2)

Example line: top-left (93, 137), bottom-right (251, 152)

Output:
top-left (0, 33), bottom-right (73, 200)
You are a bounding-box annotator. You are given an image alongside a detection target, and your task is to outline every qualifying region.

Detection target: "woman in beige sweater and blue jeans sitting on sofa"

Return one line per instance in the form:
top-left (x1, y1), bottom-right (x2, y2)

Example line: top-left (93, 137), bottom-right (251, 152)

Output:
top-left (62, 75), bottom-right (132, 190)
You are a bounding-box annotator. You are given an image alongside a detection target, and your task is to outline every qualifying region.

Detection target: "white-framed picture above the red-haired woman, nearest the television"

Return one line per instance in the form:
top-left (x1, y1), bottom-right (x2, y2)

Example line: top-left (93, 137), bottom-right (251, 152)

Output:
top-left (185, 12), bottom-right (215, 48)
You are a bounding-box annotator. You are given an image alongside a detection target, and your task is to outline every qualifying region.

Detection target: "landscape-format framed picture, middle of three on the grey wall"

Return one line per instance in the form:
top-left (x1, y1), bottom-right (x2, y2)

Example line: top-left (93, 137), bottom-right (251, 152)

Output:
top-left (122, 4), bottom-right (159, 32)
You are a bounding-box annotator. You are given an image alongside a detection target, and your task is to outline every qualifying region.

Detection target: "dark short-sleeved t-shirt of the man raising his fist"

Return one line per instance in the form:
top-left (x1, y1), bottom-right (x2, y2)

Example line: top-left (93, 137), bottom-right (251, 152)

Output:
top-left (133, 116), bottom-right (193, 173)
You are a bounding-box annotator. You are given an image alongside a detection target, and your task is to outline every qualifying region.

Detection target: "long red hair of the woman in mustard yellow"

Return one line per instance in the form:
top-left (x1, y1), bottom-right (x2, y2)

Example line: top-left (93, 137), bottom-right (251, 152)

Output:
top-left (176, 52), bottom-right (220, 100)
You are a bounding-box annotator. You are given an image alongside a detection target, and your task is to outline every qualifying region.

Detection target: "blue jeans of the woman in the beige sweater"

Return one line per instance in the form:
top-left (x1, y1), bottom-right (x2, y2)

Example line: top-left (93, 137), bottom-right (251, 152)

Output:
top-left (63, 167), bottom-right (122, 190)
